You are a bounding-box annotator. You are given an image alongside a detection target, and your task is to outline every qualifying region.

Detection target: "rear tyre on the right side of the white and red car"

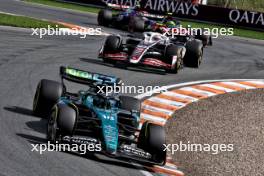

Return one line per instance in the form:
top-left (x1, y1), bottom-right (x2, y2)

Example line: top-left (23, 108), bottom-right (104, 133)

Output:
top-left (184, 39), bottom-right (203, 68)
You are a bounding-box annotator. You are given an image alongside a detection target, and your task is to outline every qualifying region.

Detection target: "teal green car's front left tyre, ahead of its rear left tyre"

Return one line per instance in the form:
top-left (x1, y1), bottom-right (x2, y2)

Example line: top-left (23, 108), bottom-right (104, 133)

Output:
top-left (47, 104), bottom-right (78, 143)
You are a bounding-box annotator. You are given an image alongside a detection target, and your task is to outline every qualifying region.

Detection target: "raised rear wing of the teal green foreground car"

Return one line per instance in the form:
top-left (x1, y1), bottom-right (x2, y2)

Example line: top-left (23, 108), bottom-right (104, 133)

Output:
top-left (60, 66), bottom-right (121, 86)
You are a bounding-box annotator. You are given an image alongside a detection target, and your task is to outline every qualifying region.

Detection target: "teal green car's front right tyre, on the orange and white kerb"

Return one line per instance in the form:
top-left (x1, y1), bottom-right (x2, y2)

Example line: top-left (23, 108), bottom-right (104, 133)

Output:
top-left (137, 121), bottom-right (167, 165)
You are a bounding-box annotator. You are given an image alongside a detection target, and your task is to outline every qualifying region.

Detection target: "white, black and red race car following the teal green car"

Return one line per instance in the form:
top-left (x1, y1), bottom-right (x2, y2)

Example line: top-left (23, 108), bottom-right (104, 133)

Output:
top-left (99, 32), bottom-right (203, 73)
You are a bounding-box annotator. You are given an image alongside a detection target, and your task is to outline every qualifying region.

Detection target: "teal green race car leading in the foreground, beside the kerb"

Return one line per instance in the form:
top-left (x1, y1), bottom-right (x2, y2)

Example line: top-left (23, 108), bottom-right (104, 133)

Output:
top-left (33, 67), bottom-right (166, 165)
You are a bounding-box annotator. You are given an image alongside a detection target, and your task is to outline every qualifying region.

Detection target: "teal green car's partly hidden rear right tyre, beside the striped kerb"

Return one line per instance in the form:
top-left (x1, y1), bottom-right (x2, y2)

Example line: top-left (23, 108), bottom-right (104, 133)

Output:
top-left (119, 96), bottom-right (141, 112)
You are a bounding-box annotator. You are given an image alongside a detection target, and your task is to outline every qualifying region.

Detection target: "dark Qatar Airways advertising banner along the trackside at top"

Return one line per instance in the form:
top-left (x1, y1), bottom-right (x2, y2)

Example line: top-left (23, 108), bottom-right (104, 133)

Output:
top-left (66, 0), bottom-right (264, 30)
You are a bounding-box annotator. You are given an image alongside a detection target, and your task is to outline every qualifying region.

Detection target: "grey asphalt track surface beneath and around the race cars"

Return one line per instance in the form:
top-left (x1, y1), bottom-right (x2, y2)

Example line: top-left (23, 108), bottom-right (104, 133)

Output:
top-left (0, 0), bottom-right (264, 176)
